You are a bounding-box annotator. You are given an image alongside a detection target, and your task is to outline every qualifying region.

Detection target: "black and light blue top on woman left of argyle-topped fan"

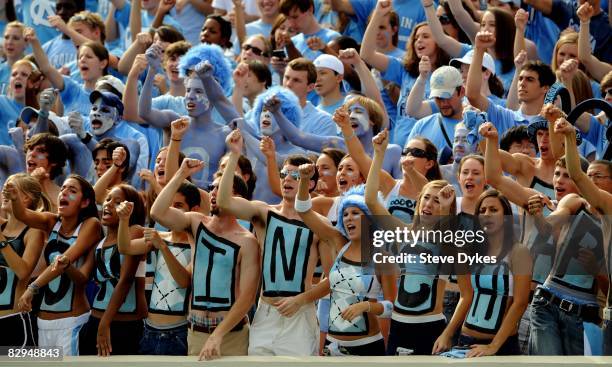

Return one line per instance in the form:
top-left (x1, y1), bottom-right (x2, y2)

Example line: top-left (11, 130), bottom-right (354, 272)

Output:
top-left (92, 238), bottom-right (140, 314)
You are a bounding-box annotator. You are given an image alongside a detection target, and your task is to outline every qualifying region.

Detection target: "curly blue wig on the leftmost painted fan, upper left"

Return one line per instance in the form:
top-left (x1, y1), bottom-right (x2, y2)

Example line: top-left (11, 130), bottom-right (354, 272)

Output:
top-left (179, 44), bottom-right (232, 91)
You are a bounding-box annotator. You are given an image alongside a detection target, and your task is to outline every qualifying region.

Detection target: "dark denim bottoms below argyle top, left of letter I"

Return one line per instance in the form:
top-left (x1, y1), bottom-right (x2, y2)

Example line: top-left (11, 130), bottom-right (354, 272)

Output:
top-left (140, 323), bottom-right (187, 356)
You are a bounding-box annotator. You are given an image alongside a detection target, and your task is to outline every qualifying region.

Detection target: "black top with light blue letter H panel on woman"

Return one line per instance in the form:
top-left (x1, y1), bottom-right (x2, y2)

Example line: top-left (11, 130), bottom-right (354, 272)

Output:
top-left (465, 255), bottom-right (514, 334)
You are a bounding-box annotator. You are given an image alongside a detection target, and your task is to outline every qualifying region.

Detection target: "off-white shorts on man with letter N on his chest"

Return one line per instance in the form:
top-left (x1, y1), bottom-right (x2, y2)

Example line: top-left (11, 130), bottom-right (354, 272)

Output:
top-left (249, 301), bottom-right (319, 356)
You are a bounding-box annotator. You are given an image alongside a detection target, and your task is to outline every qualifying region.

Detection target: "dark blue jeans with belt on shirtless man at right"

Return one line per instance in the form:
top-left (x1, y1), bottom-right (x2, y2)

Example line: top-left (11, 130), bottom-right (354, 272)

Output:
top-left (529, 295), bottom-right (584, 356)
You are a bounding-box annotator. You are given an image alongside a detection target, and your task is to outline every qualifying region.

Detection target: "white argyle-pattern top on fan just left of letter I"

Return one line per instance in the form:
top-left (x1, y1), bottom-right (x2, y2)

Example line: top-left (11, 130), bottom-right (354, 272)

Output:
top-left (149, 240), bottom-right (191, 315)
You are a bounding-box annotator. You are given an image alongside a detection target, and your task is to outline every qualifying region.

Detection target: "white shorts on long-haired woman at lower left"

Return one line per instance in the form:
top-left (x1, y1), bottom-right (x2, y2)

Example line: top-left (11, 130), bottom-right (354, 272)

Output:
top-left (37, 311), bottom-right (90, 356)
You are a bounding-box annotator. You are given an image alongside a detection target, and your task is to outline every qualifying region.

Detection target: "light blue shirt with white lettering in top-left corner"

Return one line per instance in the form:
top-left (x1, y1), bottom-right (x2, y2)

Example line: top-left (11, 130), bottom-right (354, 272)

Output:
top-left (14, 0), bottom-right (60, 44)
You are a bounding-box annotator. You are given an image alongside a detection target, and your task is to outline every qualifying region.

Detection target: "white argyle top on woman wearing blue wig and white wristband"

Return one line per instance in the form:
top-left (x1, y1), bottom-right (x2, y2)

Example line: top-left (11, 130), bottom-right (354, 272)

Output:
top-left (329, 242), bottom-right (382, 335)
